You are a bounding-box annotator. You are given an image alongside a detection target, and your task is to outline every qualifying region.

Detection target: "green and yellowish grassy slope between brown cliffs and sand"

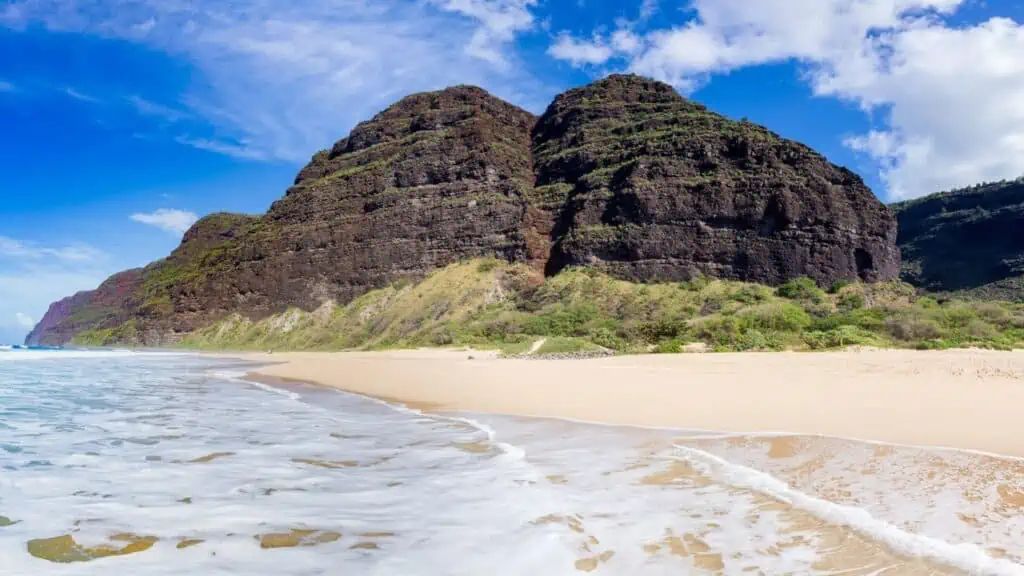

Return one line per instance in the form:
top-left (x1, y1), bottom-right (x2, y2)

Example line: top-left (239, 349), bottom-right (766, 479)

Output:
top-left (182, 260), bottom-right (1024, 354)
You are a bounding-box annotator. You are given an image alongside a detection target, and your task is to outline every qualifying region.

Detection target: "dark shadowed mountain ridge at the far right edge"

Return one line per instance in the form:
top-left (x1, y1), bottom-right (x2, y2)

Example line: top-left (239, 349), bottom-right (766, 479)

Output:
top-left (892, 178), bottom-right (1024, 300)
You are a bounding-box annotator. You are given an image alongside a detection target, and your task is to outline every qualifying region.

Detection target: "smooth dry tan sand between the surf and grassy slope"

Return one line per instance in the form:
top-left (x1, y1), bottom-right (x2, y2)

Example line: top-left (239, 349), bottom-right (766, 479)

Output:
top-left (228, 351), bottom-right (1024, 457)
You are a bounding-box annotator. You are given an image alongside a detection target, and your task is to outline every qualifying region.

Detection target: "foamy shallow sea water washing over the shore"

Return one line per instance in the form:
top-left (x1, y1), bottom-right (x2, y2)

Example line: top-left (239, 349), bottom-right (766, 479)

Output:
top-left (0, 351), bottom-right (1024, 576)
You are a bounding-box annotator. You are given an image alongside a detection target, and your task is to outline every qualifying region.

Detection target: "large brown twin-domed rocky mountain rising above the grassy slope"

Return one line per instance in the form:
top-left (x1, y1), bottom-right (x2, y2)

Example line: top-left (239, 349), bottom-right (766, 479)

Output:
top-left (29, 75), bottom-right (899, 345)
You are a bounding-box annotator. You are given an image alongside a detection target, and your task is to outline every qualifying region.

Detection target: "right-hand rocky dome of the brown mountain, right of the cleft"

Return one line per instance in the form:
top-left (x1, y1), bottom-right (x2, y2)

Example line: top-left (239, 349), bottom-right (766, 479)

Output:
top-left (534, 77), bottom-right (899, 285)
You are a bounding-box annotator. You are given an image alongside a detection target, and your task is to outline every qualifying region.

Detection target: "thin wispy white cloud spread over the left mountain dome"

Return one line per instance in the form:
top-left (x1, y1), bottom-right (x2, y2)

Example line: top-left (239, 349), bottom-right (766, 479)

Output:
top-left (0, 0), bottom-right (549, 162)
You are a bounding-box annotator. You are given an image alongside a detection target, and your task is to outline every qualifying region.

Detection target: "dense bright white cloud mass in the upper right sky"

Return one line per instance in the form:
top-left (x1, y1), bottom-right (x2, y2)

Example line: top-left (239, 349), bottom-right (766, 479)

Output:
top-left (552, 0), bottom-right (1024, 199)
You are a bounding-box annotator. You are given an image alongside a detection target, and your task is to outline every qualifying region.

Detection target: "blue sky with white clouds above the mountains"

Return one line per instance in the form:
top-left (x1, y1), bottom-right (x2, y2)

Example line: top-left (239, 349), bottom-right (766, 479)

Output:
top-left (0, 0), bottom-right (1024, 342)
